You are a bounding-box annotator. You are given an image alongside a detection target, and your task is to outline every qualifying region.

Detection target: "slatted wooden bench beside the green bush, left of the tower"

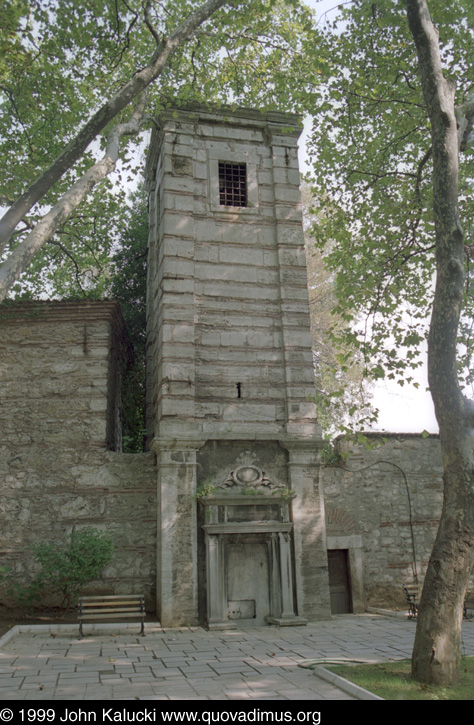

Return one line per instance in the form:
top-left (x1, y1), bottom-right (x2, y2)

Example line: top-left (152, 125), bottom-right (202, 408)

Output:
top-left (78, 594), bottom-right (145, 637)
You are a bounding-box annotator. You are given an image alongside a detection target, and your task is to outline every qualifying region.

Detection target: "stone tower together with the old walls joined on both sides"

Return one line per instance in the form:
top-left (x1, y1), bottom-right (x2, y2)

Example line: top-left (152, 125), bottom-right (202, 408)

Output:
top-left (0, 113), bottom-right (464, 629)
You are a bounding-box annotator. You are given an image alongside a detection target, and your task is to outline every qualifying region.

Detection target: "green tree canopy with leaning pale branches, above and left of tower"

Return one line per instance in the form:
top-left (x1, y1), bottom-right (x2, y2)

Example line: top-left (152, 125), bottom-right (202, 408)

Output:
top-left (0, 0), bottom-right (323, 298)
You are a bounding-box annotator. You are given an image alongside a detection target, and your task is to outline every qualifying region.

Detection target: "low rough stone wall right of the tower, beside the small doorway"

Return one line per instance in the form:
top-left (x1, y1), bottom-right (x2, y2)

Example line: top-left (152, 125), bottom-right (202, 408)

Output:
top-left (322, 434), bottom-right (452, 609)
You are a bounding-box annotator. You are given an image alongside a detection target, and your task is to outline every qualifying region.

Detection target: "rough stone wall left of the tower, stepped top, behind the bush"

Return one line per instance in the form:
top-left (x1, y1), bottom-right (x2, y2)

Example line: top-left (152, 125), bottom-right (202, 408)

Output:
top-left (0, 302), bottom-right (156, 608)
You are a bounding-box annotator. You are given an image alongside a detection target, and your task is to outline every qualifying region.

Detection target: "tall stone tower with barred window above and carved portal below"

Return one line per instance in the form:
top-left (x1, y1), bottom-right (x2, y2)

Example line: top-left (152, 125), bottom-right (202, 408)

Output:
top-left (147, 107), bottom-right (330, 628)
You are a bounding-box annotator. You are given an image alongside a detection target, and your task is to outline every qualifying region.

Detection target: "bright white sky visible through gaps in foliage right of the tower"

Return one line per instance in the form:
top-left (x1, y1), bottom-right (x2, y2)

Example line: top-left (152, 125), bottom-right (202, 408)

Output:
top-left (299, 0), bottom-right (438, 433)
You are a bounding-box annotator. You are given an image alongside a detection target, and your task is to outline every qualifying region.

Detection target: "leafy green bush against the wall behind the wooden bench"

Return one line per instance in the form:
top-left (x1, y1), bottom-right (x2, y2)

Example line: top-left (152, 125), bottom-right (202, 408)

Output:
top-left (30, 528), bottom-right (114, 610)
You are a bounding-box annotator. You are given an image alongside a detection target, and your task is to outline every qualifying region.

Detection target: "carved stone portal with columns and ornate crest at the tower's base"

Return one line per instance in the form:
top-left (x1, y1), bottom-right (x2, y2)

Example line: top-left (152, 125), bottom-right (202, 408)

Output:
top-left (200, 465), bottom-right (306, 629)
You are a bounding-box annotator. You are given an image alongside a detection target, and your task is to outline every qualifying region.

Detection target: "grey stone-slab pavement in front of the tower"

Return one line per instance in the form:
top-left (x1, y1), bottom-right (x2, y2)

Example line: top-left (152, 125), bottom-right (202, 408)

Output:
top-left (0, 613), bottom-right (474, 701)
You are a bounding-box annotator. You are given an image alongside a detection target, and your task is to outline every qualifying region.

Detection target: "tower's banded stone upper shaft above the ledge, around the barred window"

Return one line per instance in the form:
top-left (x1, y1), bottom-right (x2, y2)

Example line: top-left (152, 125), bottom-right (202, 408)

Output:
top-left (148, 108), bottom-right (320, 438)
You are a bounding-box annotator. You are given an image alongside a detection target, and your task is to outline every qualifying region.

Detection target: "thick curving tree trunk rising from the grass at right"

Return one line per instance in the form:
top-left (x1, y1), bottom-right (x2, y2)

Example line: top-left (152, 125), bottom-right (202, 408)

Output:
top-left (406, 0), bottom-right (474, 685)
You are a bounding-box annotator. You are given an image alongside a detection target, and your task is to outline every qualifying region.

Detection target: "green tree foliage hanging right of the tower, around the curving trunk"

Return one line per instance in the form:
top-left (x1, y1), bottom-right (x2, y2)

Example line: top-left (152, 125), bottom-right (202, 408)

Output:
top-left (311, 0), bottom-right (474, 396)
